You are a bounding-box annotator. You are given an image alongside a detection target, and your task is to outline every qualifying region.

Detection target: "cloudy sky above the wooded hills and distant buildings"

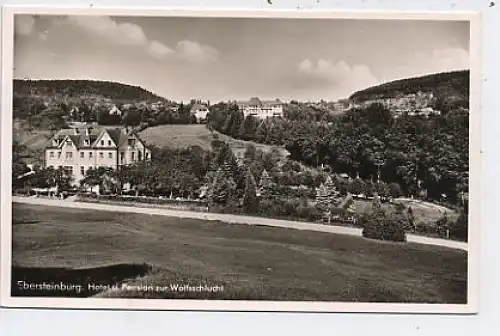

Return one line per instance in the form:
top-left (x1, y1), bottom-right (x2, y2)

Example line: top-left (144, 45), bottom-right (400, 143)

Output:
top-left (14, 15), bottom-right (469, 101)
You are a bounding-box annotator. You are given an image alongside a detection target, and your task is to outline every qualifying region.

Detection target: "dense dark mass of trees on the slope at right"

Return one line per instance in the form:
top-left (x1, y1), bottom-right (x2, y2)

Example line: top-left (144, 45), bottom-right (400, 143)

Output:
top-left (209, 104), bottom-right (469, 202)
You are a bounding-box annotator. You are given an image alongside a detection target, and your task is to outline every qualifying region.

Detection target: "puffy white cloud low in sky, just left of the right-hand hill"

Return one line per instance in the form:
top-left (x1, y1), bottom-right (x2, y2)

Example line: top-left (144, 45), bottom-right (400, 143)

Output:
top-left (297, 59), bottom-right (377, 94)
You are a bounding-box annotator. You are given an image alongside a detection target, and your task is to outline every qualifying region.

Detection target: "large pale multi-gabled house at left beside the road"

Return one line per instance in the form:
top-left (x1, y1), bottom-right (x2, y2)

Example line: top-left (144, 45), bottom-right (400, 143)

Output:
top-left (45, 126), bottom-right (151, 185)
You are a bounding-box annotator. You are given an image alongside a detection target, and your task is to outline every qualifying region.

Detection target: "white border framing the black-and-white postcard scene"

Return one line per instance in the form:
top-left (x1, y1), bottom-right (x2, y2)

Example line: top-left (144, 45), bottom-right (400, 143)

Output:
top-left (0, 6), bottom-right (482, 314)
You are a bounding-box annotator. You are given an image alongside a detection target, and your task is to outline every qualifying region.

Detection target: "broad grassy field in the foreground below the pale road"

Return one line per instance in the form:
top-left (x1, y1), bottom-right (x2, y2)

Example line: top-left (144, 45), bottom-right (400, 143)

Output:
top-left (13, 204), bottom-right (467, 303)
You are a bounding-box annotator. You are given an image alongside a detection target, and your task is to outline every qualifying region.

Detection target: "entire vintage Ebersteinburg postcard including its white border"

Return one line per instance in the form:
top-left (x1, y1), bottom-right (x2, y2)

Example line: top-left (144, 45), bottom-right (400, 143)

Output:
top-left (1, 7), bottom-right (481, 314)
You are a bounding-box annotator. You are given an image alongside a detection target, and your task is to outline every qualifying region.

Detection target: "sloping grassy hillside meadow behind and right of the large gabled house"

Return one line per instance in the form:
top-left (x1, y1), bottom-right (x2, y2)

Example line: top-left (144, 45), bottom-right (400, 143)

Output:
top-left (140, 125), bottom-right (288, 157)
